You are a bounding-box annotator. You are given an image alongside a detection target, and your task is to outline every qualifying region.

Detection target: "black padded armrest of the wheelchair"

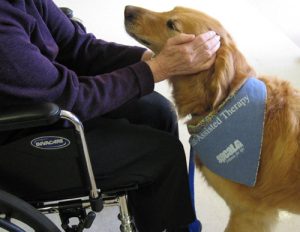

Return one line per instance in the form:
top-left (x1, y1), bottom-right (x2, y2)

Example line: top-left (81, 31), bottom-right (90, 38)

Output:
top-left (0, 103), bottom-right (60, 131)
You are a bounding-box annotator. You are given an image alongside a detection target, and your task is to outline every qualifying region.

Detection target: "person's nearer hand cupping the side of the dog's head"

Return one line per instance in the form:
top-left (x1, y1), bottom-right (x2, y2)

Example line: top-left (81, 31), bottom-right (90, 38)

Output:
top-left (145, 31), bottom-right (220, 82)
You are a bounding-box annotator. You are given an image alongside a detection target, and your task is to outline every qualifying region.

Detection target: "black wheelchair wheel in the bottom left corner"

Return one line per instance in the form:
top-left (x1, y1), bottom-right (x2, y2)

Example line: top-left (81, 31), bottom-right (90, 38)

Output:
top-left (0, 190), bottom-right (61, 232)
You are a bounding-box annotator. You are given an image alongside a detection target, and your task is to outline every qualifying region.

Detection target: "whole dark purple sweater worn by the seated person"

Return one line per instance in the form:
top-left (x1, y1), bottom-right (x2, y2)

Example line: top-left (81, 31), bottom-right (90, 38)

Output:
top-left (0, 0), bottom-right (154, 120)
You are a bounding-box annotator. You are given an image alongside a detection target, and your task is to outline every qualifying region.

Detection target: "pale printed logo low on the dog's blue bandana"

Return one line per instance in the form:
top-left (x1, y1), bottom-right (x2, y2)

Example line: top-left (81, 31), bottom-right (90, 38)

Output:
top-left (216, 139), bottom-right (245, 164)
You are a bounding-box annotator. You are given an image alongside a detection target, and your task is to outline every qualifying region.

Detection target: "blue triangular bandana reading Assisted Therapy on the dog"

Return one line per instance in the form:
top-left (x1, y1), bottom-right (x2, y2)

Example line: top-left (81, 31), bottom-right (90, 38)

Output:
top-left (188, 78), bottom-right (267, 186)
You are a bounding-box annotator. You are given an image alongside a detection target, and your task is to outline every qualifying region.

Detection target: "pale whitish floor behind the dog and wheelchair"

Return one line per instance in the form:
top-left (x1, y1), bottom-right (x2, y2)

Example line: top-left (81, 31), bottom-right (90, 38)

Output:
top-left (50, 0), bottom-right (300, 232)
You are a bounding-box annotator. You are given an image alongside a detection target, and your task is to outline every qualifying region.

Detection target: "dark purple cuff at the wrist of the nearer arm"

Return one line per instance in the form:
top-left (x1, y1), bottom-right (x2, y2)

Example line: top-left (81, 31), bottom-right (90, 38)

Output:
top-left (130, 61), bottom-right (154, 97)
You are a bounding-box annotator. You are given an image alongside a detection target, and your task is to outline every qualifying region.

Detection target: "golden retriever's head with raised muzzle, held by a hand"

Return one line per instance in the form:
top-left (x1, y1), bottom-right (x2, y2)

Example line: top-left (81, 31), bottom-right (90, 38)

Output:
top-left (125, 6), bottom-right (253, 117)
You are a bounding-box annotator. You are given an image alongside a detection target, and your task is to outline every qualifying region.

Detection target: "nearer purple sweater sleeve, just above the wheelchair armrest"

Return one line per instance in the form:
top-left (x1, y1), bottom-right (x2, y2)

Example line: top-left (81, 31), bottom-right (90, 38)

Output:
top-left (0, 1), bottom-right (154, 120)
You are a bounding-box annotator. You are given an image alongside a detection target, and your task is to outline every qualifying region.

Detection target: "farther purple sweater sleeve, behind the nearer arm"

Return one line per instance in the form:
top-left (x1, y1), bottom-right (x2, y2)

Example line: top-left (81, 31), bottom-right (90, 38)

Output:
top-left (39, 0), bottom-right (145, 75)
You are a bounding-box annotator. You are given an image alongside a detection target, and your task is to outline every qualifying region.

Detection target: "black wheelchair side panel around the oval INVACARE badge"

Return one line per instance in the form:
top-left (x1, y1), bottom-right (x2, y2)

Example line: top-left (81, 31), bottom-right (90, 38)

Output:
top-left (0, 129), bottom-right (89, 201)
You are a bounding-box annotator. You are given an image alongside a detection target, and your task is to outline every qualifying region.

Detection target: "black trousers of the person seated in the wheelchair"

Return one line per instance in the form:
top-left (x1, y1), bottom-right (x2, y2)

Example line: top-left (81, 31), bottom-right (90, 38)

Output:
top-left (84, 92), bottom-right (195, 232)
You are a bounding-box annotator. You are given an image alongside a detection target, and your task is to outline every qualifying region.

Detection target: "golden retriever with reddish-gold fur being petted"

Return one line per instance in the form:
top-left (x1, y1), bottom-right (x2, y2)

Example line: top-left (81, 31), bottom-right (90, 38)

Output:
top-left (125, 6), bottom-right (300, 232)
